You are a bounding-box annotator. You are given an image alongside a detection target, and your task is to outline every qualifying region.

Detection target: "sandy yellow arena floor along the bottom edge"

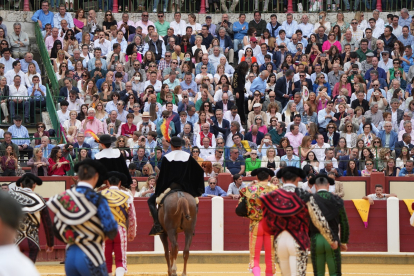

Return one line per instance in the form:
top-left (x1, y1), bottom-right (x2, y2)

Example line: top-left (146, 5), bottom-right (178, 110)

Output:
top-left (37, 264), bottom-right (414, 276)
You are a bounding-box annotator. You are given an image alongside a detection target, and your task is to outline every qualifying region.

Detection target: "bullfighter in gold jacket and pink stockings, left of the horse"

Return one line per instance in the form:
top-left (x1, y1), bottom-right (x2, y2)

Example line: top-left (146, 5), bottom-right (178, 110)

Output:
top-left (101, 171), bottom-right (137, 276)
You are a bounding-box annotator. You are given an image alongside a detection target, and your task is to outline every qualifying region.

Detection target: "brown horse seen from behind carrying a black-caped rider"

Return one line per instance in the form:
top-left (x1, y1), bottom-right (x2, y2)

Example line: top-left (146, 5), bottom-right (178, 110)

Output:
top-left (158, 192), bottom-right (197, 276)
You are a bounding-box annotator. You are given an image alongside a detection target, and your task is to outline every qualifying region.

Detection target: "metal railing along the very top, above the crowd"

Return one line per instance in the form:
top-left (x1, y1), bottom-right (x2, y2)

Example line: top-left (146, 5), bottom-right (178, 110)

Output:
top-left (4, 0), bottom-right (413, 13)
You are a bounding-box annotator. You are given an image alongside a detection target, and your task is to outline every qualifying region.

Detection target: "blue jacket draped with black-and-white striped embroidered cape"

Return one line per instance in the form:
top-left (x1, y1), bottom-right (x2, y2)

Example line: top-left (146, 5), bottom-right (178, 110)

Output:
top-left (47, 182), bottom-right (118, 267)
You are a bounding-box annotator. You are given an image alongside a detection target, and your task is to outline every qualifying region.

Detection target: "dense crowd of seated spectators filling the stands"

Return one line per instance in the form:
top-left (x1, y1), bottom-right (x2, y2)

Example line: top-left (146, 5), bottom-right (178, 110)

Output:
top-left (0, 1), bottom-right (414, 192)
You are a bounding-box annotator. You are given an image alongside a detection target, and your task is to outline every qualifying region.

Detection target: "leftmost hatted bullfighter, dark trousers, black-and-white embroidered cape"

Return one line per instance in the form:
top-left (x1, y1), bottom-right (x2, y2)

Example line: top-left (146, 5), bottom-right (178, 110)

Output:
top-left (9, 173), bottom-right (55, 263)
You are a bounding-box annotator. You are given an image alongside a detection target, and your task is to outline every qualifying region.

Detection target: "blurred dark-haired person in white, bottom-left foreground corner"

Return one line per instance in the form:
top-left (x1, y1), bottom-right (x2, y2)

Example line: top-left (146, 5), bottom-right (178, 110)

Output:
top-left (0, 191), bottom-right (40, 276)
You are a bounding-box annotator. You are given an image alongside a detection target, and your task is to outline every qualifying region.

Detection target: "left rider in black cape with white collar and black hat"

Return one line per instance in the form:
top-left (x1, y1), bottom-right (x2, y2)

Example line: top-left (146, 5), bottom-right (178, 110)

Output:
top-left (95, 134), bottom-right (132, 186)
